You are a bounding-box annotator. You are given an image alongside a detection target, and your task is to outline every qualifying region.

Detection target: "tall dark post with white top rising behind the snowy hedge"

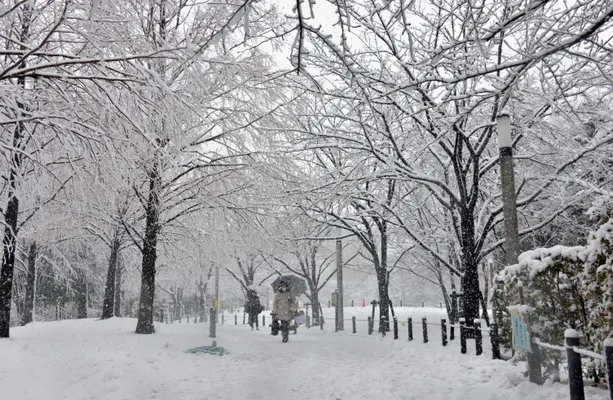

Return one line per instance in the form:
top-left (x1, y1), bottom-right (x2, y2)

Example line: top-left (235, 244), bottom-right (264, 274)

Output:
top-left (497, 114), bottom-right (519, 265)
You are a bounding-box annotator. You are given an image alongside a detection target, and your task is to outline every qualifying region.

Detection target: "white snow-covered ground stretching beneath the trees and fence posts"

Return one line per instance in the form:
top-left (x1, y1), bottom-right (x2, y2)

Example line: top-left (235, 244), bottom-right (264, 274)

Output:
top-left (0, 315), bottom-right (608, 400)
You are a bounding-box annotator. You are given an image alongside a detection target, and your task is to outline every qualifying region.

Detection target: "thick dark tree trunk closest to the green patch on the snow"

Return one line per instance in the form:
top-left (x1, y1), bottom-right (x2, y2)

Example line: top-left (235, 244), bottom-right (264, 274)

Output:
top-left (136, 156), bottom-right (161, 334)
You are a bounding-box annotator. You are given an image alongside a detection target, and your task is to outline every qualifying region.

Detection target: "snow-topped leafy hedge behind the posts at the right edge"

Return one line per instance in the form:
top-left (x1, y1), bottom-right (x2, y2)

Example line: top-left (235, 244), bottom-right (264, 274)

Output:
top-left (493, 218), bottom-right (613, 376)
